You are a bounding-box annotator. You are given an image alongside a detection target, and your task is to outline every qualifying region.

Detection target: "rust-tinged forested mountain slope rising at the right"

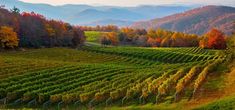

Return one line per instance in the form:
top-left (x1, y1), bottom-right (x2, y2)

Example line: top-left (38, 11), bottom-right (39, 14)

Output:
top-left (131, 6), bottom-right (235, 34)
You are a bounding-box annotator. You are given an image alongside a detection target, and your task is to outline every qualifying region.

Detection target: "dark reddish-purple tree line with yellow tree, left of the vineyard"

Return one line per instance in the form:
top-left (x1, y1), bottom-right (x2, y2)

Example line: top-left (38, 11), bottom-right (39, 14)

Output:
top-left (0, 7), bottom-right (85, 48)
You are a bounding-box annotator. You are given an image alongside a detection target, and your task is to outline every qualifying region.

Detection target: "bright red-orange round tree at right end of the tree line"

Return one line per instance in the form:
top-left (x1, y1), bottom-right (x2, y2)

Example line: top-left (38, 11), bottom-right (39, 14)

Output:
top-left (206, 28), bottom-right (227, 49)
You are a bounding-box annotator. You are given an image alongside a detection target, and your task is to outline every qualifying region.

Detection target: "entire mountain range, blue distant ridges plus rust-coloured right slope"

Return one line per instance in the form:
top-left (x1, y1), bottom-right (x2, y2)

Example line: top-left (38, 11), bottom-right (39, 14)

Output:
top-left (0, 0), bottom-right (235, 35)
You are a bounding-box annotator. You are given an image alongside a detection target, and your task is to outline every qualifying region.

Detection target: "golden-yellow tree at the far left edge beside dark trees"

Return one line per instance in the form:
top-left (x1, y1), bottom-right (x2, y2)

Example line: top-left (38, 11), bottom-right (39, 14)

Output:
top-left (0, 26), bottom-right (19, 48)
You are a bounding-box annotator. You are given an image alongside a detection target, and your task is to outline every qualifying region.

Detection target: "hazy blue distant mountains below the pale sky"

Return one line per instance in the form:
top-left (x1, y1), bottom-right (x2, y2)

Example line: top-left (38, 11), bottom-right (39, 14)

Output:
top-left (0, 0), bottom-right (196, 26)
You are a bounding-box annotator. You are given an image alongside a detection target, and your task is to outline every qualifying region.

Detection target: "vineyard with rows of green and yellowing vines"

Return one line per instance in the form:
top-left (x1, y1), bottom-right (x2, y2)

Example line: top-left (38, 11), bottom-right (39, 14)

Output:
top-left (0, 47), bottom-right (226, 108)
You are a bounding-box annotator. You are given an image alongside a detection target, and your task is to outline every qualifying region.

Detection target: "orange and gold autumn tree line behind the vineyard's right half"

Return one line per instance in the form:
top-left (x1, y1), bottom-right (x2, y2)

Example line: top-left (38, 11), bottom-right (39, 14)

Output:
top-left (100, 27), bottom-right (227, 49)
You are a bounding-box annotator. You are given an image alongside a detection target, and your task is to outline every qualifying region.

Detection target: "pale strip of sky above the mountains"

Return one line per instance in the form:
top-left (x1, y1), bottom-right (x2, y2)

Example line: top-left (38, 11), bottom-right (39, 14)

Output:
top-left (20, 0), bottom-right (235, 7)
